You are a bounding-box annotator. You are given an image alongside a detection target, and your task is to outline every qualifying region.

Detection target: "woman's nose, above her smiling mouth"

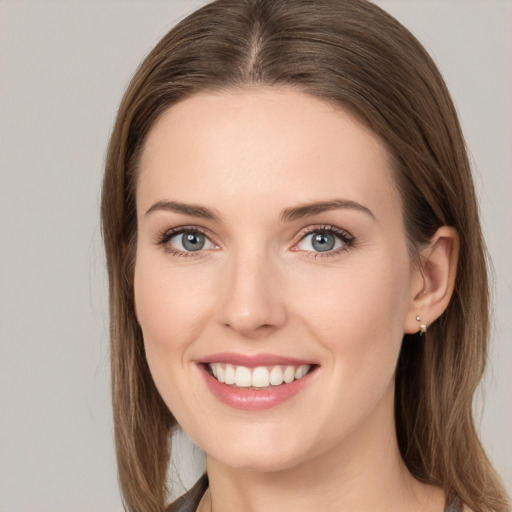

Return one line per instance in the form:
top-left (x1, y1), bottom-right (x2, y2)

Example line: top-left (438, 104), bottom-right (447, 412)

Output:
top-left (219, 249), bottom-right (287, 339)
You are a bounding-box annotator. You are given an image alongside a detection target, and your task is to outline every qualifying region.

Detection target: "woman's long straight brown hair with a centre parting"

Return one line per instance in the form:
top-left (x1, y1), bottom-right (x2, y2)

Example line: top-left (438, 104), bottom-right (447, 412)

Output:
top-left (102, 0), bottom-right (508, 512)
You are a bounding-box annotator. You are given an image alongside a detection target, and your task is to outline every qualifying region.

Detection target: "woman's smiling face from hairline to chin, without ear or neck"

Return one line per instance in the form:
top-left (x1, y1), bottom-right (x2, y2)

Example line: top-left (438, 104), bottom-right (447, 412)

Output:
top-left (135, 88), bottom-right (422, 471)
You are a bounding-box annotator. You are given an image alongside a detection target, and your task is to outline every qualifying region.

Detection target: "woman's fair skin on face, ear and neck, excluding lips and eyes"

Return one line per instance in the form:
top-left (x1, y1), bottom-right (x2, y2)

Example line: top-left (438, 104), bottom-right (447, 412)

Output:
top-left (134, 88), bottom-right (457, 512)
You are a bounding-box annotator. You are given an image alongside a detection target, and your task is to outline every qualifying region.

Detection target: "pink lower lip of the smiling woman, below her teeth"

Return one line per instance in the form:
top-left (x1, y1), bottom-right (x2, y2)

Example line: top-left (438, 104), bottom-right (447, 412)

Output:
top-left (199, 364), bottom-right (316, 411)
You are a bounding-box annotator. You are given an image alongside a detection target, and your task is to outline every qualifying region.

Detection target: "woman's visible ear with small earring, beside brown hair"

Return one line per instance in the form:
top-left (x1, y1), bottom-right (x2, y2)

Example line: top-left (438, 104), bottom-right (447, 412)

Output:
top-left (404, 226), bottom-right (459, 334)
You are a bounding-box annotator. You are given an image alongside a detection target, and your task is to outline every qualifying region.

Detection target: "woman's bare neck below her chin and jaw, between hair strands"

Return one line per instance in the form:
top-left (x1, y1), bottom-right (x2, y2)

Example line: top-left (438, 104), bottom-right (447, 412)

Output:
top-left (198, 384), bottom-right (444, 512)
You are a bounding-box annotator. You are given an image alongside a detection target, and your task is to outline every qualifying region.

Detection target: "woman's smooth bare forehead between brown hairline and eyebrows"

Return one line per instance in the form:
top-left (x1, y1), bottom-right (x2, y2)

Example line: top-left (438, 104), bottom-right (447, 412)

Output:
top-left (137, 88), bottom-right (397, 222)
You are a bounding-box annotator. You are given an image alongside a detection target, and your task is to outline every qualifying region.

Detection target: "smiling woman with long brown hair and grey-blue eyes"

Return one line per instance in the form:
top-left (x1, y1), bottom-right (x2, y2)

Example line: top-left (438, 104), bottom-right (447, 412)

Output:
top-left (102, 0), bottom-right (508, 512)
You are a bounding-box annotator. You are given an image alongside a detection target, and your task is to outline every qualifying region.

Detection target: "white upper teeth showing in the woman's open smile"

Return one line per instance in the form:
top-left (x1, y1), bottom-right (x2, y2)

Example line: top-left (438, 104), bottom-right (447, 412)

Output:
top-left (206, 363), bottom-right (316, 390)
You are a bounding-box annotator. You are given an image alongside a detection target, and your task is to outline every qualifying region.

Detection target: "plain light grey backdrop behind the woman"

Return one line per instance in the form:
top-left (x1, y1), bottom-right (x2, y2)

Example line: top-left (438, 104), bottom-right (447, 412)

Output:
top-left (0, 0), bottom-right (512, 512)
